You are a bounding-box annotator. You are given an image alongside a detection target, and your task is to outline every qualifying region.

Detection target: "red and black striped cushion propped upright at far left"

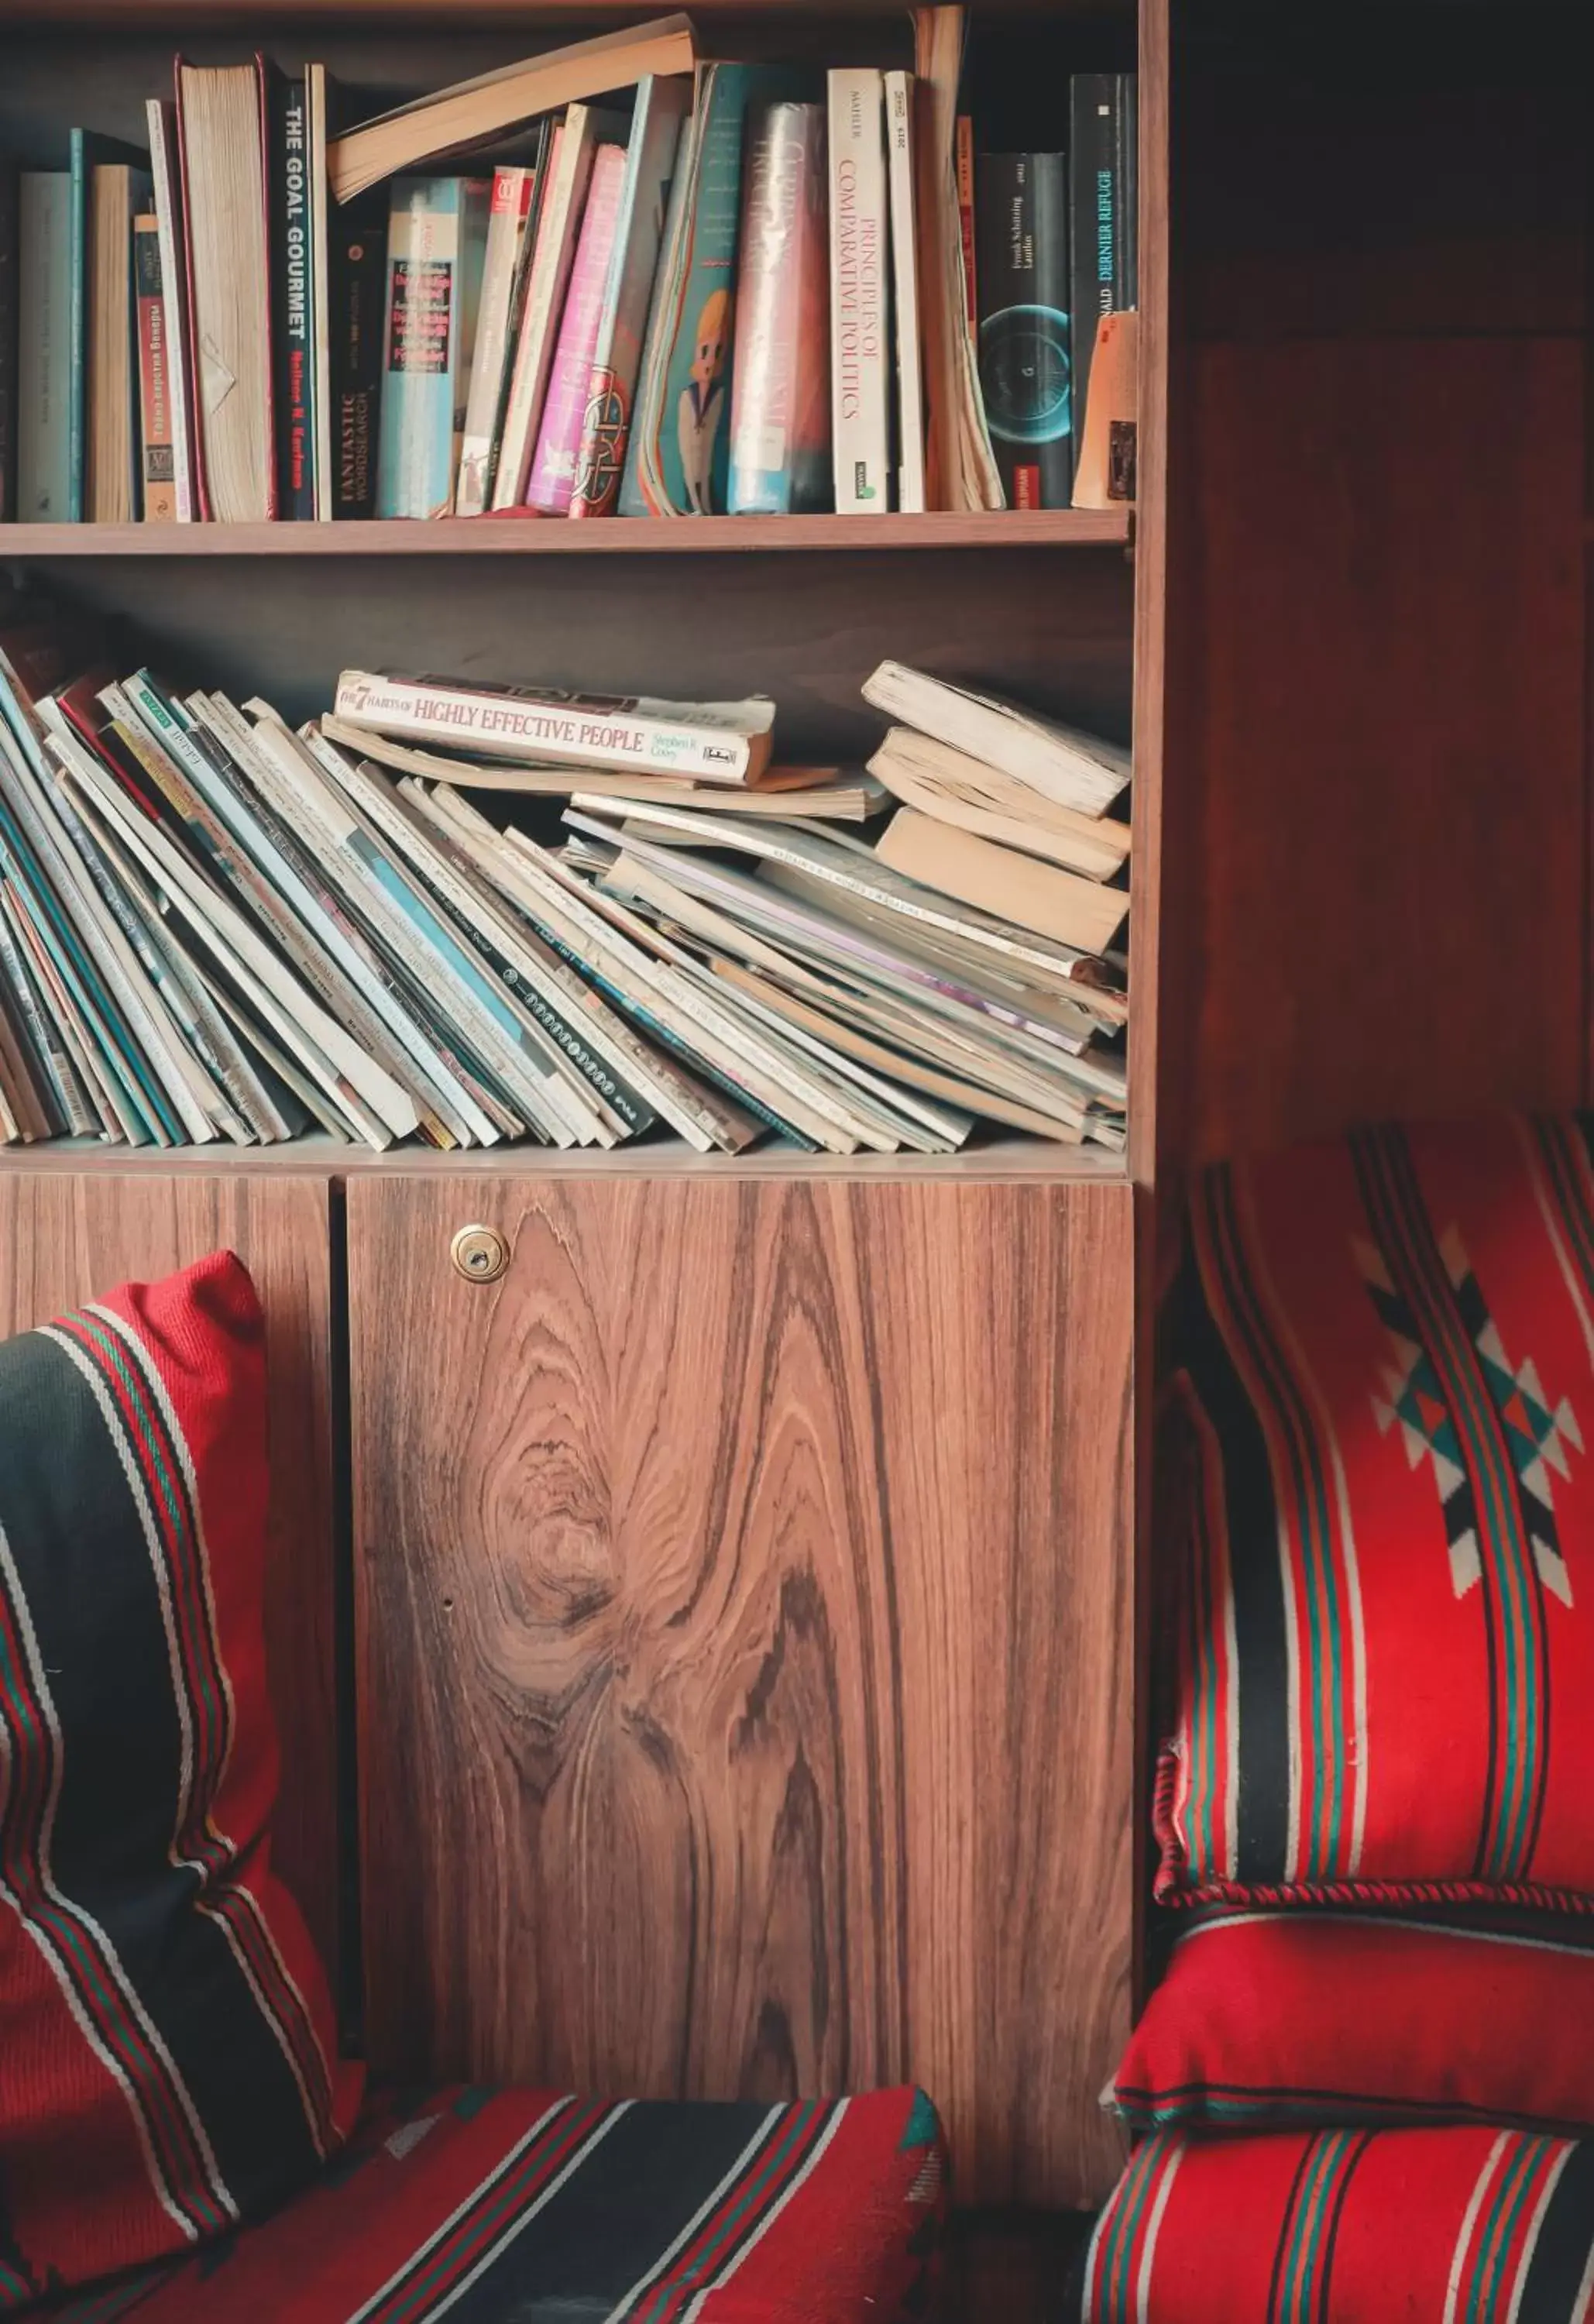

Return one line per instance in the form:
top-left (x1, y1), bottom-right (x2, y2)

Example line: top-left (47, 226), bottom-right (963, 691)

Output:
top-left (0, 1255), bottom-right (360, 2312)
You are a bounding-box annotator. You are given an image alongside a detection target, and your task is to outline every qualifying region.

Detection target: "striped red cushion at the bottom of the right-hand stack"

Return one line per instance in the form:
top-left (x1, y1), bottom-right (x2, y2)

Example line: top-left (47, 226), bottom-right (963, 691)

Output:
top-left (1069, 2129), bottom-right (1594, 2324)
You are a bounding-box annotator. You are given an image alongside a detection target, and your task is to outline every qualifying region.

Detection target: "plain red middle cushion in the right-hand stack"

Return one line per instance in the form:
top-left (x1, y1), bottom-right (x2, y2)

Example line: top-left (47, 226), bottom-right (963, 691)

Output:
top-left (1113, 1908), bottom-right (1594, 2133)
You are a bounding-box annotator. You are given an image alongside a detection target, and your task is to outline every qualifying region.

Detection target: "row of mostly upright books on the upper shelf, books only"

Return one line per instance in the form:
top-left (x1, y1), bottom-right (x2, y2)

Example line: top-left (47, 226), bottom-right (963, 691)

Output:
top-left (0, 7), bottom-right (1136, 523)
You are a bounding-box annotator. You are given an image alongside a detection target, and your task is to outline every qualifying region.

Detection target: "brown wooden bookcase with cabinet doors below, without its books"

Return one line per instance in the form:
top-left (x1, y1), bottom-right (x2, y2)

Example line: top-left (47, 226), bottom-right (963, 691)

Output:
top-left (0, 0), bottom-right (1169, 2250)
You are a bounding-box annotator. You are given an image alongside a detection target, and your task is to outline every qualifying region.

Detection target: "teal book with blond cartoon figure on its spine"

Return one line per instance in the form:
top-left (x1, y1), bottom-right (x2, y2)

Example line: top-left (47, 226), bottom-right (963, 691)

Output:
top-left (620, 65), bottom-right (813, 516)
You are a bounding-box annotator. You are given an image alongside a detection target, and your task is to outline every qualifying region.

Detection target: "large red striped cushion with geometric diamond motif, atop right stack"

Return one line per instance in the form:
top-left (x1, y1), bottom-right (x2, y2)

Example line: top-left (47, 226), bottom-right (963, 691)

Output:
top-left (1157, 1118), bottom-right (1594, 1910)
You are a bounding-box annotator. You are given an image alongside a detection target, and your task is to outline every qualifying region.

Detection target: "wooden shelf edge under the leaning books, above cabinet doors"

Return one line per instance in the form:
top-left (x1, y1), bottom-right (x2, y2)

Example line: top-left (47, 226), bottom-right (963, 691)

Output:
top-left (0, 1136), bottom-right (1127, 1185)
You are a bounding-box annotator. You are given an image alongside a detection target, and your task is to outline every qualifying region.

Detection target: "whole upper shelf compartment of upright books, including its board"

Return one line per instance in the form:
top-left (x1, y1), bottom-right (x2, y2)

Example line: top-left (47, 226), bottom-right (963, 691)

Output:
top-left (0, 0), bottom-right (1139, 555)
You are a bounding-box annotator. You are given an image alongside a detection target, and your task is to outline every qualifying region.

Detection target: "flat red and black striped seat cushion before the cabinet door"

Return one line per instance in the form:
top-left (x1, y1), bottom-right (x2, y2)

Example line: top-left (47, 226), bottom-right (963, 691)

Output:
top-left (42, 2087), bottom-right (946, 2324)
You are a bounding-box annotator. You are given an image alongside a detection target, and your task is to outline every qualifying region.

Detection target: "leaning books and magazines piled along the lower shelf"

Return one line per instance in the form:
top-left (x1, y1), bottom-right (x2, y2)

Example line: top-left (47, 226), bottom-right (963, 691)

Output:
top-left (0, 597), bottom-right (1129, 1155)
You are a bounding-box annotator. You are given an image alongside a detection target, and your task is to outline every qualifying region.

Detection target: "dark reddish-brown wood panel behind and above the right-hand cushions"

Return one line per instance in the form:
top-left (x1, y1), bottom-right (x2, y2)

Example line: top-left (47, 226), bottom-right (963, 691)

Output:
top-left (1159, 339), bottom-right (1587, 1155)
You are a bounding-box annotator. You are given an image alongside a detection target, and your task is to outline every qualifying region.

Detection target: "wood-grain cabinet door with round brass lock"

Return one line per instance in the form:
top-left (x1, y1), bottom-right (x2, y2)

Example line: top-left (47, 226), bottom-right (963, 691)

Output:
top-left (349, 1171), bottom-right (1132, 2203)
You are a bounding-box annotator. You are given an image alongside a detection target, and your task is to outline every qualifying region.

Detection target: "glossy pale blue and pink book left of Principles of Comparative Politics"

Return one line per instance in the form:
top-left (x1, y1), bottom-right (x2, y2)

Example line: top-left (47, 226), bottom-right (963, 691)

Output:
top-left (727, 105), bottom-right (830, 516)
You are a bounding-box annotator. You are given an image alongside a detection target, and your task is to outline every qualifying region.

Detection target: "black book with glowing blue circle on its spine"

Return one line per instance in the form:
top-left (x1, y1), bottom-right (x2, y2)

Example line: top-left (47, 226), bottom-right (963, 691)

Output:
top-left (974, 153), bottom-right (1074, 509)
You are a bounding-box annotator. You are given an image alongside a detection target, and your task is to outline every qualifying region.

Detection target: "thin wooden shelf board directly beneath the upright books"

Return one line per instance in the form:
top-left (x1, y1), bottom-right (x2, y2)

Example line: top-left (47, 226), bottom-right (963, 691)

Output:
top-left (0, 509), bottom-right (1132, 558)
